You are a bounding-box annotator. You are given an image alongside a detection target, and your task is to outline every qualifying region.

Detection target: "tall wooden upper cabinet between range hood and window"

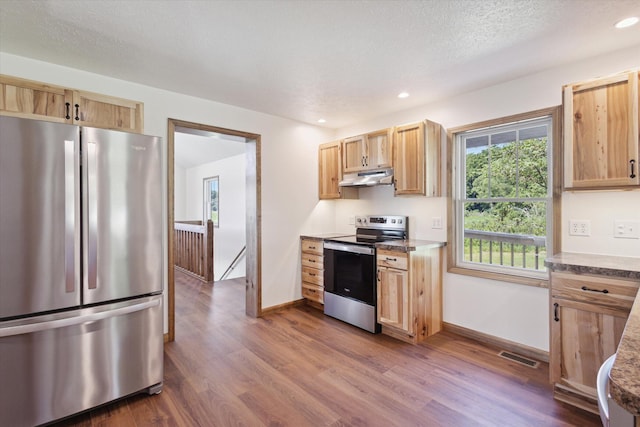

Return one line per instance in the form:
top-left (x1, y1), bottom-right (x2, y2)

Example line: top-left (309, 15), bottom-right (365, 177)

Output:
top-left (393, 120), bottom-right (442, 197)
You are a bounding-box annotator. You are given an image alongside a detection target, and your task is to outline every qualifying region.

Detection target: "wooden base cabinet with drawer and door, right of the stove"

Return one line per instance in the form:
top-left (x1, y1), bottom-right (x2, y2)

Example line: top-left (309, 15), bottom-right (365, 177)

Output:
top-left (376, 246), bottom-right (442, 344)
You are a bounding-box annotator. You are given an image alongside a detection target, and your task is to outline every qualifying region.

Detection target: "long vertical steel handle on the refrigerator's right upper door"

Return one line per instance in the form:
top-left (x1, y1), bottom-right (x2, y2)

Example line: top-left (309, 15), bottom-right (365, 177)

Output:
top-left (85, 142), bottom-right (98, 289)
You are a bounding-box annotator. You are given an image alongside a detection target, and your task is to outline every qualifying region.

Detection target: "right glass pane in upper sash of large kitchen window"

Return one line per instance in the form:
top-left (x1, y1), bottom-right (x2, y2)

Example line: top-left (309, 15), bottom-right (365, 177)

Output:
top-left (518, 126), bottom-right (549, 197)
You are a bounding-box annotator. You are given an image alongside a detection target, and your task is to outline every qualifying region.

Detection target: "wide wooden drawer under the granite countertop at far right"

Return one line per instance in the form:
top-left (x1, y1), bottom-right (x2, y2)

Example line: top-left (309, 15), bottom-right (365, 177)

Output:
top-left (551, 272), bottom-right (640, 310)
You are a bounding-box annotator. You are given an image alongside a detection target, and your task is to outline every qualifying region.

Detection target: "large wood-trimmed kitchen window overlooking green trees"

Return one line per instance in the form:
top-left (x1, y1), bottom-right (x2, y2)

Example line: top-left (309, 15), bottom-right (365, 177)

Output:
top-left (449, 109), bottom-right (557, 283)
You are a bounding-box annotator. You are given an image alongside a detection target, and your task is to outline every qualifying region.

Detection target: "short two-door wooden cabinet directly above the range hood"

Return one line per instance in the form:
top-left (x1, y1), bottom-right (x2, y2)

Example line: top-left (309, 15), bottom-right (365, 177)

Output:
top-left (342, 129), bottom-right (393, 173)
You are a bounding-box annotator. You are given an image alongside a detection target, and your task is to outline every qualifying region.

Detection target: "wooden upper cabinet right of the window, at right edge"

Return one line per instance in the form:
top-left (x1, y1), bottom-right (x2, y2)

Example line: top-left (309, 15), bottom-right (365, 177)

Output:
top-left (563, 71), bottom-right (640, 189)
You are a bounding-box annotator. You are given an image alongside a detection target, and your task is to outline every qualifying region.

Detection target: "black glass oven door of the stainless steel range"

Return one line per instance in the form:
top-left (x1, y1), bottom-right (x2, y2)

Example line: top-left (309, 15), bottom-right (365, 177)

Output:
top-left (324, 241), bottom-right (376, 307)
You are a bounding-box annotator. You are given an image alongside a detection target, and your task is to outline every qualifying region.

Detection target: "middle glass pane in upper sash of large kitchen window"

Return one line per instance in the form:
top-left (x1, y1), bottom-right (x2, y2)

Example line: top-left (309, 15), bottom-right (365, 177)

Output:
top-left (489, 131), bottom-right (518, 197)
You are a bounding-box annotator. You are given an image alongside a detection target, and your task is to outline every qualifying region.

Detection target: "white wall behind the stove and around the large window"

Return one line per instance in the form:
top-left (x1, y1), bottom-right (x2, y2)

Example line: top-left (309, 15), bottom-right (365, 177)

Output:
top-left (336, 46), bottom-right (640, 351)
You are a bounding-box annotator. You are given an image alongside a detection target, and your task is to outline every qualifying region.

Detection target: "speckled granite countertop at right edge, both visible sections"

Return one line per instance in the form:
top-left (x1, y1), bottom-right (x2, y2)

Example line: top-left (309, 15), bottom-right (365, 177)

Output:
top-left (545, 253), bottom-right (640, 416)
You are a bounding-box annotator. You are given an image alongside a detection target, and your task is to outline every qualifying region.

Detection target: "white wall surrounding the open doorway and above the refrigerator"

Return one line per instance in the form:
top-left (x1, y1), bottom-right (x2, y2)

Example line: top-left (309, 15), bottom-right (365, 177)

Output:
top-left (0, 52), bottom-right (334, 331)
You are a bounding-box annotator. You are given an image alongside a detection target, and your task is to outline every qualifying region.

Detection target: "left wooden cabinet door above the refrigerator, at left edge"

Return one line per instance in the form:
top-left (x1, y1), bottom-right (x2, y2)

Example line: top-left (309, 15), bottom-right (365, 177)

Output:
top-left (0, 76), bottom-right (73, 123)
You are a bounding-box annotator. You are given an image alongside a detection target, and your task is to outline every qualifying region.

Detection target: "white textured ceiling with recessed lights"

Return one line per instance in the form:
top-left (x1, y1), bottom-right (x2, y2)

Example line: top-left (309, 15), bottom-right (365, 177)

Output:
top-left (0, 0), bottom-right (640, 128)
